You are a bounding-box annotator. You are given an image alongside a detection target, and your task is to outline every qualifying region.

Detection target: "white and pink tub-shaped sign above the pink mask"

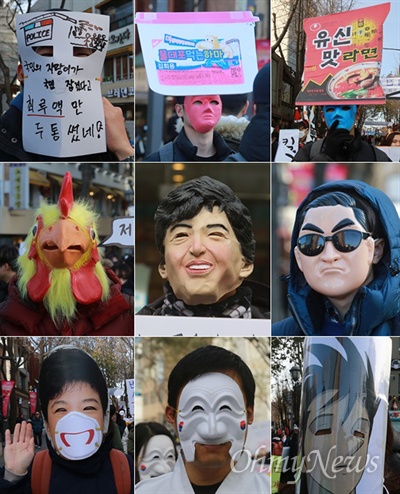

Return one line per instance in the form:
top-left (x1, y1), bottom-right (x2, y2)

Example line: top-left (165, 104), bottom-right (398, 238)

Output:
top-left (135, 12), bottom-right (259, 96)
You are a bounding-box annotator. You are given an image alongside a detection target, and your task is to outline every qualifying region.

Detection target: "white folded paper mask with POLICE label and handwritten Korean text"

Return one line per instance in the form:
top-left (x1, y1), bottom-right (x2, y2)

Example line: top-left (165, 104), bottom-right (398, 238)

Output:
top-left (17, 12), bottom-right (110, 157)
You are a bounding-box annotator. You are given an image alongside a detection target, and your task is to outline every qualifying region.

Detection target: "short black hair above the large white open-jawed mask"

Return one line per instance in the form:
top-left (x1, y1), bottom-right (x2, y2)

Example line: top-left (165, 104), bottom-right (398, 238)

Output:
top-left (168, 345), bottom-right (256, 409)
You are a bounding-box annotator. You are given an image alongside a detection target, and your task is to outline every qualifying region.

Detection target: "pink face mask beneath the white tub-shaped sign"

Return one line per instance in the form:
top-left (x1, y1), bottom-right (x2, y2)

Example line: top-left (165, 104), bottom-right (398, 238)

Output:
top-left (184, 95), bottom-right (222, 134)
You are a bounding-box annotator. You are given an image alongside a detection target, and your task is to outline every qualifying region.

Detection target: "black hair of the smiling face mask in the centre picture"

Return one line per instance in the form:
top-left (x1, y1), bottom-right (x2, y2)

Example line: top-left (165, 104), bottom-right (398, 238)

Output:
top-left (154, 177), bottom-right (256, 264)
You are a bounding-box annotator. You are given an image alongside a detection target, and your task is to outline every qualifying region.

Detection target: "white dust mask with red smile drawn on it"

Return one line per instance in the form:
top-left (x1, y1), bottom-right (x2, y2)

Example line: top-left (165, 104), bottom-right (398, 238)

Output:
top-left (54, 412), bottom-right (103, 460)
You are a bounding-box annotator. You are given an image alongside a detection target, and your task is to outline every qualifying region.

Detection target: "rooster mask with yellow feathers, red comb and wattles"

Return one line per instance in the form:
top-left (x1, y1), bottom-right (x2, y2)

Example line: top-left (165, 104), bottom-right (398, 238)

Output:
top-left (18, 172), bottom-right (109, 321)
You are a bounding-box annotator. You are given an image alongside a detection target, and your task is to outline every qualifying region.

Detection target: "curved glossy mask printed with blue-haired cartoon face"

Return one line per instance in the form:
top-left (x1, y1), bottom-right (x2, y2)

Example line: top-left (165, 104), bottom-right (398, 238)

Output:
top-left (296, 336), bottom-right (392, 494)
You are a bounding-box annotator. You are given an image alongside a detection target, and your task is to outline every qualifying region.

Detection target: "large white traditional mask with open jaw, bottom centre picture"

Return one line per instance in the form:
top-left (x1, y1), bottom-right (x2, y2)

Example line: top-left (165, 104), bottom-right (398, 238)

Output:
top-left (177, 372), bottom-right (247, 462)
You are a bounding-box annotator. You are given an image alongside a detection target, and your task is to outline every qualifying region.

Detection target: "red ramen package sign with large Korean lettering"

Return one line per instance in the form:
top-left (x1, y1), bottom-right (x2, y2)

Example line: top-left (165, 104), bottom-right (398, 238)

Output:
top-left (296, 3), bottom-right (390, 105)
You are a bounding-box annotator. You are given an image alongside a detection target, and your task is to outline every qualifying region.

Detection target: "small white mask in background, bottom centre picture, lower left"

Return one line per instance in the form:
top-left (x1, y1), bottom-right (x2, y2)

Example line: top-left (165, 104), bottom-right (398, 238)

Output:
top-left (138, 434), bottom-right (175, 480)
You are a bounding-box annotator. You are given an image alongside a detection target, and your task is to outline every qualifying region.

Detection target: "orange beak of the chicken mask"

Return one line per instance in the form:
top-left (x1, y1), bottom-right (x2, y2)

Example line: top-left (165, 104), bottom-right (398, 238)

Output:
top-left (38, 218), bottom-right (90, 269)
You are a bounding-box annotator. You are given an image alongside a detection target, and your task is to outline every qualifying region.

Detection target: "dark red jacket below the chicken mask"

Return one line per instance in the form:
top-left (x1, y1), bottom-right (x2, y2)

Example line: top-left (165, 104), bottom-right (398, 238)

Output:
top-left (0, 270), bottom-right (134, 336)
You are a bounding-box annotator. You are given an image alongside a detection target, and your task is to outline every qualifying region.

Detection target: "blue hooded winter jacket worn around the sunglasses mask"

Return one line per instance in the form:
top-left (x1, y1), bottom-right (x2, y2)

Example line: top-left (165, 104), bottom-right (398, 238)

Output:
top-left (272, 180), bottom-right (400, 336)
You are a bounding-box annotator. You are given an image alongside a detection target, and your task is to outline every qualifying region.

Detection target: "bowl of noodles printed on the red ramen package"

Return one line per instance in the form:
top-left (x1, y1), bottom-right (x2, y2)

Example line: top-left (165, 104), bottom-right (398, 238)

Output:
top-left (327, 62), bottom-right (384, 100)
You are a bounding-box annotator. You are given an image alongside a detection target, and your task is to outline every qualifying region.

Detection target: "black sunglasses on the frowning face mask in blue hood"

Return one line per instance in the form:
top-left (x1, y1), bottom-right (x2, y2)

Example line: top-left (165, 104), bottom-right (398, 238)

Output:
top-left (297, 230), bottom-right (371, 257)
